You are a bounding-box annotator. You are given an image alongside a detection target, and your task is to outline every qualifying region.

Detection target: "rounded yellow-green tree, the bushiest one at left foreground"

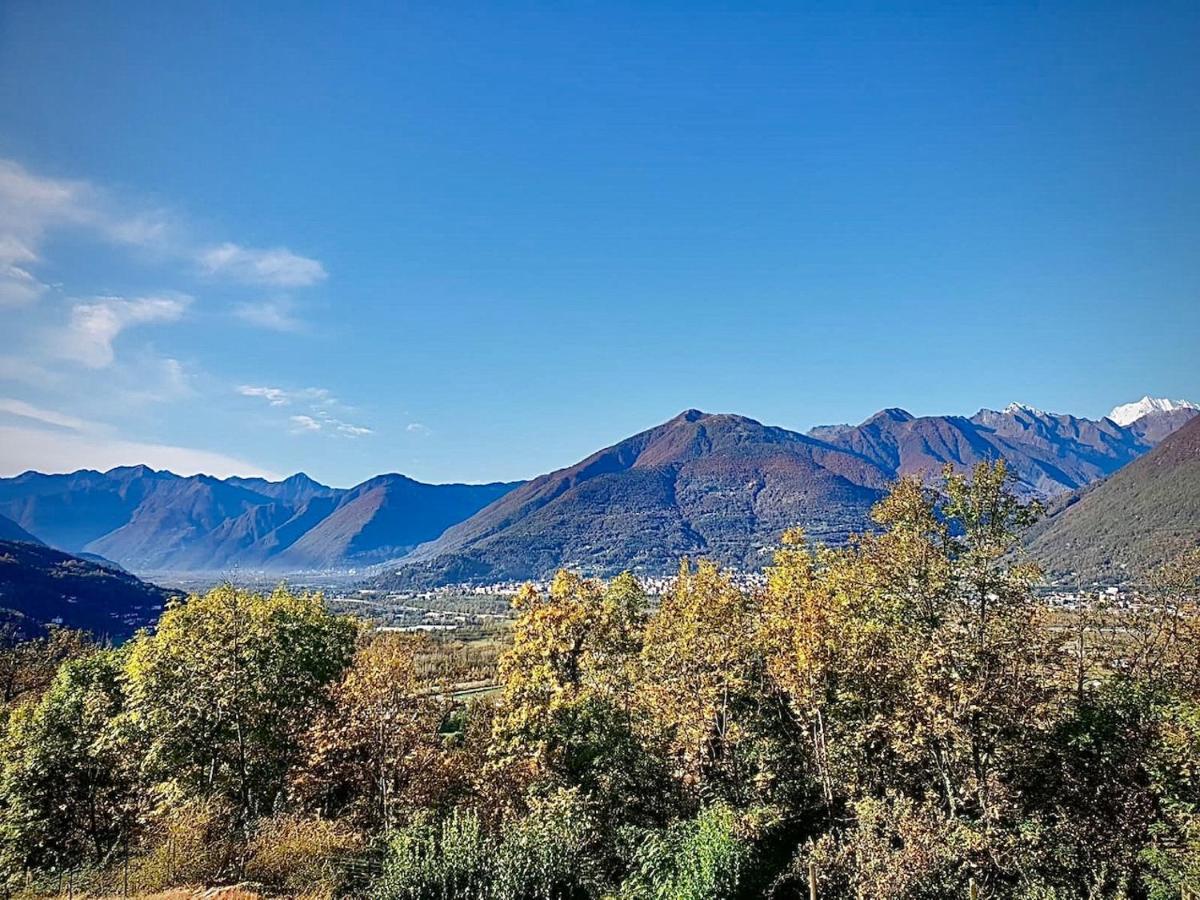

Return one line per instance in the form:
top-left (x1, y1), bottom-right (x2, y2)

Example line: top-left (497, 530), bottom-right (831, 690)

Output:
top-left (127, 584), bottom-right (356, 833)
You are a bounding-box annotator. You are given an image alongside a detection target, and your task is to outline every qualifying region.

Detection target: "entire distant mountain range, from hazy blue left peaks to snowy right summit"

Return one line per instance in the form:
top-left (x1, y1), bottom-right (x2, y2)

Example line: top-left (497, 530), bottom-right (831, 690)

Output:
top-left (0, 397), bottom-right (1198, 587)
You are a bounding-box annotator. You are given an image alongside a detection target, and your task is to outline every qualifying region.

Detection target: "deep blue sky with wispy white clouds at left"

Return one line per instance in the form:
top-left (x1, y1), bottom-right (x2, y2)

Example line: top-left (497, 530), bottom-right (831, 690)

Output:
top-left (0, 0), bottom-right (1200, 486)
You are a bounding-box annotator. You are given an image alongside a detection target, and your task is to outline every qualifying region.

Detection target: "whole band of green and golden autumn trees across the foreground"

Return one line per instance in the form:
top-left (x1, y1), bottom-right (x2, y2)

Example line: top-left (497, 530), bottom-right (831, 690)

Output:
top-left (0, 463), bottom-right (1200, 900)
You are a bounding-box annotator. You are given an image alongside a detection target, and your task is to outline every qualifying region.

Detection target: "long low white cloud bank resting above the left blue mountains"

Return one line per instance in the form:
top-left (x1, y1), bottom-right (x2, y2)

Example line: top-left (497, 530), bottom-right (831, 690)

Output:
top-left (0, 425), bottom-right (281, 480)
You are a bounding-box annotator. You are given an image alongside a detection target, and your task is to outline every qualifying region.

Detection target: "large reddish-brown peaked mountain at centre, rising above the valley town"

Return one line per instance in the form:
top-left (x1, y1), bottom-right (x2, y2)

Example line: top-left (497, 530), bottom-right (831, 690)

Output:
top-left (384, 409), bottom-right (892, 583)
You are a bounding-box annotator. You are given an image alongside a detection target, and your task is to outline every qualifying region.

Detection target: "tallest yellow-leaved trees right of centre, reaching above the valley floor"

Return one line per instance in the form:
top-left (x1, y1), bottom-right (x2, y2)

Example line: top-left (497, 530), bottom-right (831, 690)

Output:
top-left (764, 462), bottom-right (1062, 893)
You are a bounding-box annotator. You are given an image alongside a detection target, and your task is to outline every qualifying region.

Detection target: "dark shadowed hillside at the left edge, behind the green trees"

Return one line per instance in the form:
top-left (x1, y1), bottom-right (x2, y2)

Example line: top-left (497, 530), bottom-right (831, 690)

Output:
top-left (0, 541), bottom-right (175, 640)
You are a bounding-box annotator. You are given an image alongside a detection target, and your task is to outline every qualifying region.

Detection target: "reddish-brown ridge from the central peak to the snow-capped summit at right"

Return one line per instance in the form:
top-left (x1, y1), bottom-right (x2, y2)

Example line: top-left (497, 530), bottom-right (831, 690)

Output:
top-left (377, 403), bottom-right (1195, 587)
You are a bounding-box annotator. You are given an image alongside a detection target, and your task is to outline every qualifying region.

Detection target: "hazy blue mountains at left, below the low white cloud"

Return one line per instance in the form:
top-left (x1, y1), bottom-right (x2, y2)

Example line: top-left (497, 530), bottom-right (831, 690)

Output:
top-left (0, 466), bottom-right (512, 572)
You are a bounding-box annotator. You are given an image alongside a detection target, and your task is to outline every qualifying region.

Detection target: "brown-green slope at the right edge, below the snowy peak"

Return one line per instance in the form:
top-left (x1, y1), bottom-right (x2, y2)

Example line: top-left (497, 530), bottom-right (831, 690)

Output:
top-left (1027, 418), bottom-right (1200, 583)
